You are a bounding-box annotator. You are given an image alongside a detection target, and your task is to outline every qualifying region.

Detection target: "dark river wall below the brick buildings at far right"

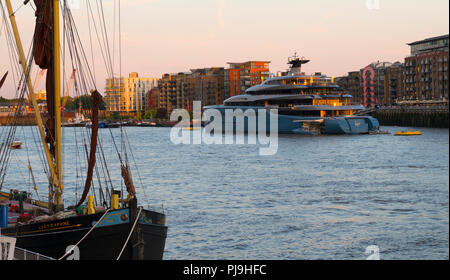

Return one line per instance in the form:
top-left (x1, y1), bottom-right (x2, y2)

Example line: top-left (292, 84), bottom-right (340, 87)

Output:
top-left (373, 108), bottom-right (449, 128)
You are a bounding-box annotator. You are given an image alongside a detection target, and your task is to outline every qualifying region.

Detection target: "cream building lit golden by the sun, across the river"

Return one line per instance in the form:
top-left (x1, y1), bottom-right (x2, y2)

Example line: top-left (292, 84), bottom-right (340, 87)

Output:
top-left (104, 72), bottom-right (158, 112)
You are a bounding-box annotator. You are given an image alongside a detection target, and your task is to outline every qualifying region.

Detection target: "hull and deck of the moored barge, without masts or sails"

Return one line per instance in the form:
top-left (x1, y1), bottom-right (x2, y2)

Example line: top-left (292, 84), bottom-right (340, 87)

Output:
top-left (0, 191), bottom-right (167, 260)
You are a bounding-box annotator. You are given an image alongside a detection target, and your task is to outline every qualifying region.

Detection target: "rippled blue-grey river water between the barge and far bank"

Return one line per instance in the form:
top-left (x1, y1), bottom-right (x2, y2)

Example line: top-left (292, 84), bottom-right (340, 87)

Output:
top-left (0, 127), bottom-right (449, 259)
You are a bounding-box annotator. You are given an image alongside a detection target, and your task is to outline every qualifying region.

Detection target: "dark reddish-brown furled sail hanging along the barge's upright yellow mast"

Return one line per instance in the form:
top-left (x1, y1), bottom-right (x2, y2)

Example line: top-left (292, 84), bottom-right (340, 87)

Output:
top-left (33, 0), bottom-right (56, 157)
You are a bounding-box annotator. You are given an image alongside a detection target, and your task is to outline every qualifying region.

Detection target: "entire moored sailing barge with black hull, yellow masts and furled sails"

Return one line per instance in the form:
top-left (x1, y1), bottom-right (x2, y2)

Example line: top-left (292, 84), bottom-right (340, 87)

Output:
top-left (0, 0), bottom-right (167, 260)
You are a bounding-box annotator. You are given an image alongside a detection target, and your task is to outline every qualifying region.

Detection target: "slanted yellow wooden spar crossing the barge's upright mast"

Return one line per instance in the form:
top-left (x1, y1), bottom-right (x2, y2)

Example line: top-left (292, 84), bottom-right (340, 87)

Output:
top-left (5, 0), bottom-right (61, 210)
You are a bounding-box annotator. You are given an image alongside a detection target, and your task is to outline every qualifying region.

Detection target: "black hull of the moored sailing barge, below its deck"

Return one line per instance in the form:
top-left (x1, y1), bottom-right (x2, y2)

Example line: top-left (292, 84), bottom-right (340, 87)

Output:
top-left (2, 210), bottom-right (167, 260)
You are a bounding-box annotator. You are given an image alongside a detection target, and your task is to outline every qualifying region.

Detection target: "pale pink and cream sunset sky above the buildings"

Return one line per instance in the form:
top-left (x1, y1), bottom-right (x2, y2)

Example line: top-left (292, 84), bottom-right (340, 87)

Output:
top-left (0, 0), bottom-right (449, 98)
